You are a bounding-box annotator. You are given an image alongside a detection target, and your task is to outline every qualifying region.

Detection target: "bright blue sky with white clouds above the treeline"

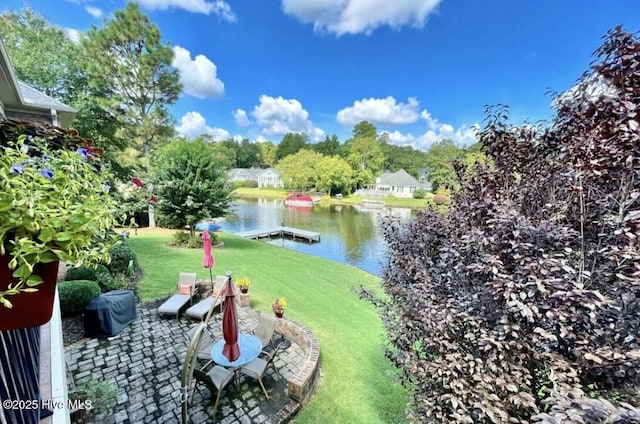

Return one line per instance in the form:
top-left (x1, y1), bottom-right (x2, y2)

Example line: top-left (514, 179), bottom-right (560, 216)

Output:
top-left (0, 0), bottom-right (640, 149)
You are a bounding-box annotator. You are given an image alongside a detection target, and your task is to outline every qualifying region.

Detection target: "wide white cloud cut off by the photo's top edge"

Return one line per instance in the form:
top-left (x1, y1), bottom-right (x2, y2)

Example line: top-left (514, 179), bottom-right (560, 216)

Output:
top-left (282, 0), bottom-right (441, 36)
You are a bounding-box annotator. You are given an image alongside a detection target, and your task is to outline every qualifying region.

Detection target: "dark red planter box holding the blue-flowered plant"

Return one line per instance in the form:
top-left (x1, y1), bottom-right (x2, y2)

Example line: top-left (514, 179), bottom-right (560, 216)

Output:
top-left (0, 256), bottom-right (58, 331)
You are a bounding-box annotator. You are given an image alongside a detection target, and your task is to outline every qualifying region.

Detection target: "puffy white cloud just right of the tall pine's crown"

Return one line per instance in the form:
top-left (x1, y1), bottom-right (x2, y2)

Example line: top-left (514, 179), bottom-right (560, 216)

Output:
top-left (172, 46), bottom-right (224, 99)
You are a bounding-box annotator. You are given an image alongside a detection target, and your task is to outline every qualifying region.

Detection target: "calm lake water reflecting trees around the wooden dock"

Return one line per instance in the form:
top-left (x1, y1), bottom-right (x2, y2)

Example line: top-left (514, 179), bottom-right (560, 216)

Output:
top-left (216, 199), bottom-right (412, 275)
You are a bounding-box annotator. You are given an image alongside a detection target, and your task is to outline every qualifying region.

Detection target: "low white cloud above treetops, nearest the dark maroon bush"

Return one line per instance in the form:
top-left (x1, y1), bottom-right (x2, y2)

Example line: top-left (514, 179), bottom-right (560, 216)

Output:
top-left (388, 110), bottom-right (480, 150)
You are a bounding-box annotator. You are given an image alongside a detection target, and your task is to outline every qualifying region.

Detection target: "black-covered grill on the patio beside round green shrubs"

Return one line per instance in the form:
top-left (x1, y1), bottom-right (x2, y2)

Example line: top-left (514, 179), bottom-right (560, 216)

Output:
top-left (84, 290), bottom-right (136, 337)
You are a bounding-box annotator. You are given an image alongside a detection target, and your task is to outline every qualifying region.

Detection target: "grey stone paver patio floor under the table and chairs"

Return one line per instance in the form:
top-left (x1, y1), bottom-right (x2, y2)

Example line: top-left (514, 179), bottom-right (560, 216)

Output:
top-left (66, 304), bottom-right (303, 424)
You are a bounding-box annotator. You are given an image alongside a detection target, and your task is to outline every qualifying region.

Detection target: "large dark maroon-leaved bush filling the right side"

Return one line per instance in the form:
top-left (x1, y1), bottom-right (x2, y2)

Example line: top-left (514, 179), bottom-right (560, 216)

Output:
top-left (363, 28), bottom-right (640, 423)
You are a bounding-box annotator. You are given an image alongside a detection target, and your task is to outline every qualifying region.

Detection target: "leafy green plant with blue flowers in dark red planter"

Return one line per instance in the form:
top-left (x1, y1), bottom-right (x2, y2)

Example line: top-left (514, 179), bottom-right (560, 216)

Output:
top-left (0, 120), bottom-right (118, 331)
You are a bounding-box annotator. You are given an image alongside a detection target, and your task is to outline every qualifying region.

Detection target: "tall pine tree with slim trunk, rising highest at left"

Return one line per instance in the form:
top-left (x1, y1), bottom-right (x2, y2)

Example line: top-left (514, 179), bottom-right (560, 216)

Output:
top-left (82, 3), bottom-right (181, 227)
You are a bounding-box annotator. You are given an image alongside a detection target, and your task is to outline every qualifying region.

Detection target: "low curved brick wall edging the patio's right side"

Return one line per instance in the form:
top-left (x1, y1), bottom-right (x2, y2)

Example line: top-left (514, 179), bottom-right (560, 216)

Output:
top-left (275, 318), bottom-right (320, 406)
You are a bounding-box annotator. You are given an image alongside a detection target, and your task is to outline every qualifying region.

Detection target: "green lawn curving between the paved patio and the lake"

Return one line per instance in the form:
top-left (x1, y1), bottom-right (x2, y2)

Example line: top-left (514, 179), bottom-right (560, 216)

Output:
top-left (130, 232), bottom-right (406, 423)
